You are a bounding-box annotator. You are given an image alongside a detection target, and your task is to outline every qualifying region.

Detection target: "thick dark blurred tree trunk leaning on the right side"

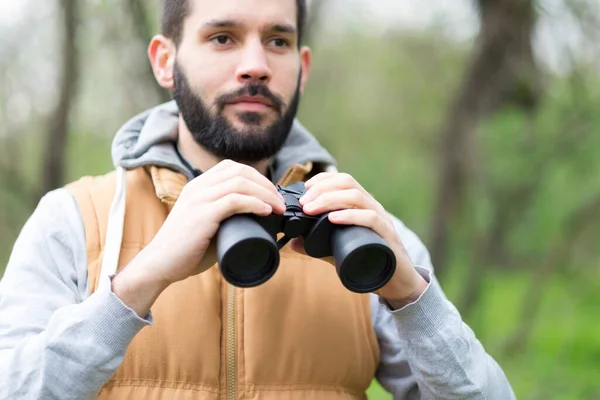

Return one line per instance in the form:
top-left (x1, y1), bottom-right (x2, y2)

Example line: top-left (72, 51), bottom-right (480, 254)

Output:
top-left (430, 0), bottom-right (540, 278)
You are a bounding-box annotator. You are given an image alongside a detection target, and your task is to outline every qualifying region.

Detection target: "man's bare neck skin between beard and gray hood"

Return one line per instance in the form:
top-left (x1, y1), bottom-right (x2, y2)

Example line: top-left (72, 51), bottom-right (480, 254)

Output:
top-left (177, 116), bottom-right (270, 176)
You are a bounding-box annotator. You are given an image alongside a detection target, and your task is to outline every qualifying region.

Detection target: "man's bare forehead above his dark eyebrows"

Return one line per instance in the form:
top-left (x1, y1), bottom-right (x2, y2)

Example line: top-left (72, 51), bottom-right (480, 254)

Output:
top-left (189, 0), bottom-right (297, 26)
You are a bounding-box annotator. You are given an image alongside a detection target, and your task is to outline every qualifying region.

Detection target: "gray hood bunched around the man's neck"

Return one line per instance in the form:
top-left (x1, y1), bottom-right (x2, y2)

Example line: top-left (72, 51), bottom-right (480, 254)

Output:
top-left (112, 101), bottom-right (336, 182)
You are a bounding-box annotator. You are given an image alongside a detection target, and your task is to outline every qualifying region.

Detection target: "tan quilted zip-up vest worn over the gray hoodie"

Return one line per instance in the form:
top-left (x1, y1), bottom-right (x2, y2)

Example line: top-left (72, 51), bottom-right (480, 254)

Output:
top-left (67, 165), bottom-right (379, 400)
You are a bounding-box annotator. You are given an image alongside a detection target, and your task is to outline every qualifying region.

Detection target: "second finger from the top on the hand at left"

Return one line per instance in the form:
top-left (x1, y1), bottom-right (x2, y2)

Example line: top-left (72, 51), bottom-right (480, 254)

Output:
top-left (201, 176), bottom-right (285, 213)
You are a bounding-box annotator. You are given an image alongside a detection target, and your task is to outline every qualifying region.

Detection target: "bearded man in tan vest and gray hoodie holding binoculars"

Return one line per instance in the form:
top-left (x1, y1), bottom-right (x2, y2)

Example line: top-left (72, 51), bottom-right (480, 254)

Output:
top-left (0, 0), bottom-right (514, 399)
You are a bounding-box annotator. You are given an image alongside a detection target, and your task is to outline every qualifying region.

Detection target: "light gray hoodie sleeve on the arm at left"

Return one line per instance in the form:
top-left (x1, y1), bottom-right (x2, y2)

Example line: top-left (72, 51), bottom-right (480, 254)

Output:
top-left (0, 189), bottom-right (151, 400)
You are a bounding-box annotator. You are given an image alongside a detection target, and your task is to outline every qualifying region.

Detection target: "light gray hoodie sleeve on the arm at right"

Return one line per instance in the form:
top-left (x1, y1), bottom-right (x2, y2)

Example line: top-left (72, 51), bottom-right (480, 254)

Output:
top-left (371, 219), bottom-right (515, 400)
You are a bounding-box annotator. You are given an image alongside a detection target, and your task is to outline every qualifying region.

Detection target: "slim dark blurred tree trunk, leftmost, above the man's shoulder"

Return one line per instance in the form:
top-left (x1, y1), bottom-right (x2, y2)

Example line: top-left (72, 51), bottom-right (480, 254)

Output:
top-left (41, 0), bottom-right (79, 193)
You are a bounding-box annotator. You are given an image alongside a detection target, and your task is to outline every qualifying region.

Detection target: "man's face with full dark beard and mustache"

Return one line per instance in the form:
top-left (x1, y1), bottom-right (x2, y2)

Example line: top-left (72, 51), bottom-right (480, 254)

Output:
top-left (173, 0), bottom-right (302, 163)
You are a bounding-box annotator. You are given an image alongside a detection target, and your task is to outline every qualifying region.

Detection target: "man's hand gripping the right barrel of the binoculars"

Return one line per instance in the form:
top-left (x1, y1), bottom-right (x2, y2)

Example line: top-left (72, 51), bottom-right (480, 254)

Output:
top-left (291, 172), bottom-right (427, 309)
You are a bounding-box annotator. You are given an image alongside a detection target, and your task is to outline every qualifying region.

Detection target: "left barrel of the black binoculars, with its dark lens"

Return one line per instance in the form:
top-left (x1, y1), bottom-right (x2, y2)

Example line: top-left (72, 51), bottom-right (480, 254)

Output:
top-left (217, 215), bottom-right (279, 287)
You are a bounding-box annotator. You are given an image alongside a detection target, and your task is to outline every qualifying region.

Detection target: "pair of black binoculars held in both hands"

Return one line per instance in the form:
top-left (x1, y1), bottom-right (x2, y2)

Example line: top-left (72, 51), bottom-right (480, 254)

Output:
top-left (217, 182), bottom-right (396, 293)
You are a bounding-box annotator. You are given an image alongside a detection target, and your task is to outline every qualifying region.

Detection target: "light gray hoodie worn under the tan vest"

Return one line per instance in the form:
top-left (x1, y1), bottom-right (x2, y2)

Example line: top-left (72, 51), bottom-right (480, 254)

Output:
top-left (0, 102), bottom-right (515, 400)
